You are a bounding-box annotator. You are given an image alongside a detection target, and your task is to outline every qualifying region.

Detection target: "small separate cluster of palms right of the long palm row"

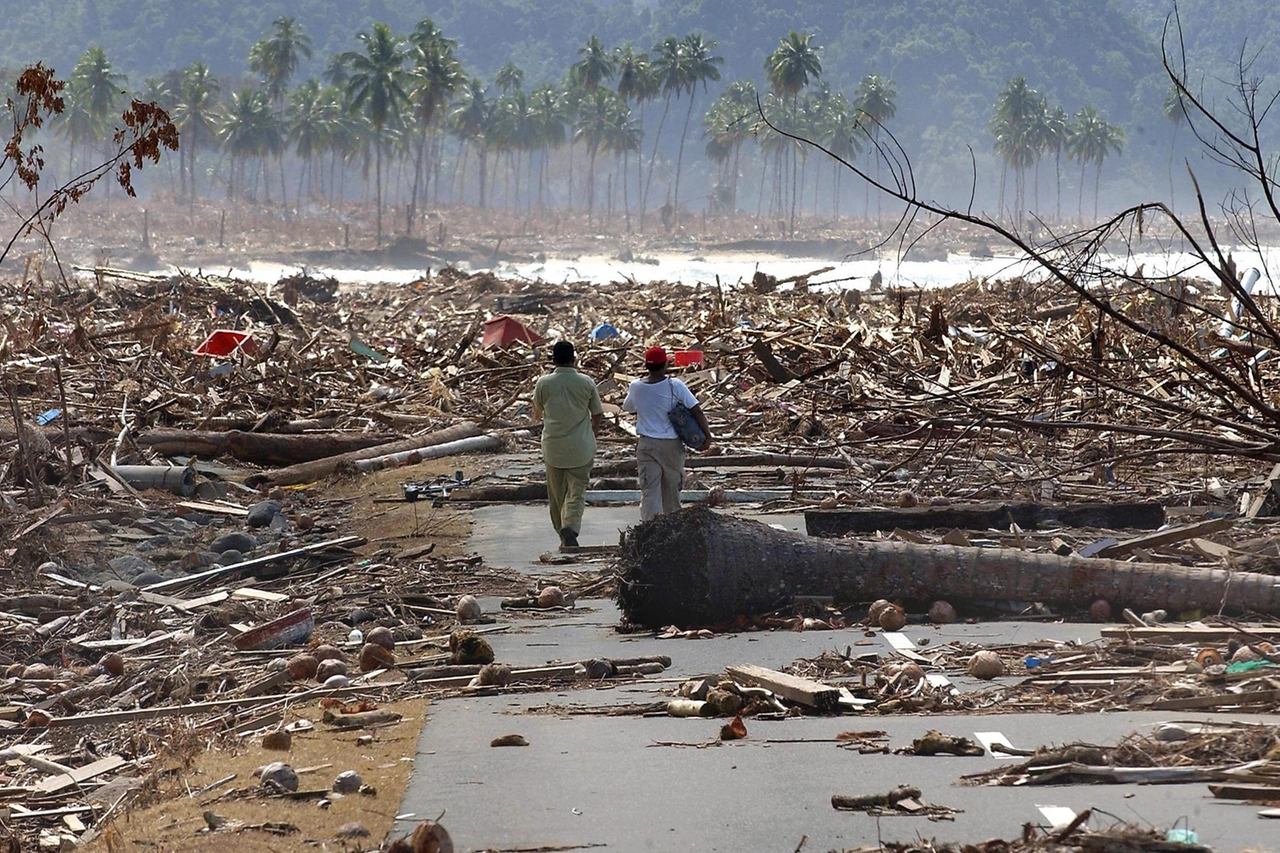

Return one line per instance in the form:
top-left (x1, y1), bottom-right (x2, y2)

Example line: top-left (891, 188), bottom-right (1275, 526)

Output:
top-left (991, 77), bottom-right (1124, 223)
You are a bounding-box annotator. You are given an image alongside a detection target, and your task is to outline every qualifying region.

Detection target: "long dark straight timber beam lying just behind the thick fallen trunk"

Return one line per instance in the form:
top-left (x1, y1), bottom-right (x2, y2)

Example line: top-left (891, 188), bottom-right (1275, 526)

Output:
top-left (804, 502), bottom-right (1165, 539)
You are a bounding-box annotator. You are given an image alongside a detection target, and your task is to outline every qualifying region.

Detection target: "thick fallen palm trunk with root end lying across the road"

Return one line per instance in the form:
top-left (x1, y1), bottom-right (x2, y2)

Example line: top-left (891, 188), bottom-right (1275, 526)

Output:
top-left (618, 507), bottom-right (1280, 628)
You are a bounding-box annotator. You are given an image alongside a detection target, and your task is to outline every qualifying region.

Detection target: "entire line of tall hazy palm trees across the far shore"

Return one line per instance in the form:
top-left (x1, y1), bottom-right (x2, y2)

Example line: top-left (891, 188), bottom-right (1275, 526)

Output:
top-left (42, 18), bottom-right (1123, 240)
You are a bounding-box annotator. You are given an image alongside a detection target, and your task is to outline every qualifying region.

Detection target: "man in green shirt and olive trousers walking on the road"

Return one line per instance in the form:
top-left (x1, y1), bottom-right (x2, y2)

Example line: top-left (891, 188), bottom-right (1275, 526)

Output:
top-left (534, 341), bottom-right (604, 548)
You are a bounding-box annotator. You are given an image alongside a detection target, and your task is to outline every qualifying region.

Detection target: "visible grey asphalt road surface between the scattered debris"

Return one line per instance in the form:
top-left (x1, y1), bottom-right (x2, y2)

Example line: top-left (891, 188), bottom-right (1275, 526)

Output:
top-left (401, 506), bottom-right (1280, 852)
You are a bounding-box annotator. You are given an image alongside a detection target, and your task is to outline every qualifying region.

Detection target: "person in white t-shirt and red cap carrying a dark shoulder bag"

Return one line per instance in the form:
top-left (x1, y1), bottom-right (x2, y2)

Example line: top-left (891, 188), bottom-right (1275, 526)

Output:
top-left (622, 347), bottom-right (712, 521)
